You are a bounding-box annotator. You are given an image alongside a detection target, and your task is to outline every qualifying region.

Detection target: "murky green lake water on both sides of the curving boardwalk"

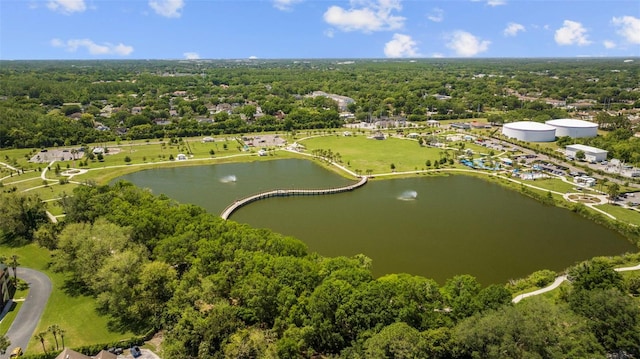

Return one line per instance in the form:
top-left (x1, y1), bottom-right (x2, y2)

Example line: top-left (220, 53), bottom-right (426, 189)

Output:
top-left (120, 160), bottom-right (637, 284)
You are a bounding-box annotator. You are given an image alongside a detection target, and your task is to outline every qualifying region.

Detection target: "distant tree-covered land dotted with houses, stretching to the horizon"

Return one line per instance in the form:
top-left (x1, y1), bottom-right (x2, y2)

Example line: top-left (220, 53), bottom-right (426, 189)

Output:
top-left (0, 59), bottom-right (640, 163)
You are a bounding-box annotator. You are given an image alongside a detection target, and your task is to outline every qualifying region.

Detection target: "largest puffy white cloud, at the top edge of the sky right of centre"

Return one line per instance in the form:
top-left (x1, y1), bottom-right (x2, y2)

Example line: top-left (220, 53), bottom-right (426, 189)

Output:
top-left (323, 0), bottom-right (405, 33)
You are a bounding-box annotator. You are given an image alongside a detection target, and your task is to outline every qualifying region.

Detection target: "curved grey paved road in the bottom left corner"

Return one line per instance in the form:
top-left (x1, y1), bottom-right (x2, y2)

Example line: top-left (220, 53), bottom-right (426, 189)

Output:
top-left (0, 267), bottom-right (52, 359)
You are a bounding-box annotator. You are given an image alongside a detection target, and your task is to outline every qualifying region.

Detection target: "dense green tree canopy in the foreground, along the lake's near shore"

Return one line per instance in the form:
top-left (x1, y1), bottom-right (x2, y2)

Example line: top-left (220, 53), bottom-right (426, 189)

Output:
top-left (0, 182), bottom-right (640, 358)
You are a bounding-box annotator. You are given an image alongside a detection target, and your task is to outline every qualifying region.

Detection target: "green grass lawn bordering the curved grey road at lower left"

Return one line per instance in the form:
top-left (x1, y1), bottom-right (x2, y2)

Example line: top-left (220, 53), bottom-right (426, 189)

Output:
top-left (0, 244), bottom-right (133, 354)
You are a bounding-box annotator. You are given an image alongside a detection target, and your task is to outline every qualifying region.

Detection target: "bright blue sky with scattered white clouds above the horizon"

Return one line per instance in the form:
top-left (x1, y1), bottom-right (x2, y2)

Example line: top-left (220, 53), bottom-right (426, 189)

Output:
top-left (0, 0), bottom-right (640, 60)
